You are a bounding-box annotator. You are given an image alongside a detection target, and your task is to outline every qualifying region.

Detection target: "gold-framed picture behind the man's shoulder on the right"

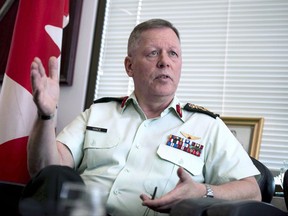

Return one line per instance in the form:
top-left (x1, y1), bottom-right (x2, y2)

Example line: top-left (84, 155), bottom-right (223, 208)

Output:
top-left (221, 116), bottom-right (264, 160)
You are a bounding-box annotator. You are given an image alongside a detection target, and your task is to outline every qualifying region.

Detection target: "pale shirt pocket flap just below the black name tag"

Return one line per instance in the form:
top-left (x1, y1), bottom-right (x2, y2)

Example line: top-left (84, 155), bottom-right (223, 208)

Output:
top-left (84, 125), bottom-right (120, 149)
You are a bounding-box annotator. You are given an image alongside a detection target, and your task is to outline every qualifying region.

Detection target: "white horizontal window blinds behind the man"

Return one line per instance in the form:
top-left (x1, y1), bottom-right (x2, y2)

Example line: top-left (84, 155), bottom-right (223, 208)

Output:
top-left (94, 0), bottom-right (288, 170)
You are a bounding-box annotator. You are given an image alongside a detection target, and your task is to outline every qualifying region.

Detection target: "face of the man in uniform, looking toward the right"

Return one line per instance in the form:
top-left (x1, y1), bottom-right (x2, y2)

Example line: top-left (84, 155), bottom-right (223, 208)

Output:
top-left (125, 28), bottom-right (182, 98)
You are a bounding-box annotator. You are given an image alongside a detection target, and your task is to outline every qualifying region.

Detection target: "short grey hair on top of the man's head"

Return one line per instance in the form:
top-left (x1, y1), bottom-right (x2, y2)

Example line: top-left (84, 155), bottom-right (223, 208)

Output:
top-left (127, 19), bottom-right (180, 55)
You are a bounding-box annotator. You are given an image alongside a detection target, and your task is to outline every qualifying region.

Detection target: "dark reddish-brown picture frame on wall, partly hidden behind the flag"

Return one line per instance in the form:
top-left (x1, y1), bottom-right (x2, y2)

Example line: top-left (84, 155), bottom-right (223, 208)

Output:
top-left (0, 0), bottom-right (83, 86)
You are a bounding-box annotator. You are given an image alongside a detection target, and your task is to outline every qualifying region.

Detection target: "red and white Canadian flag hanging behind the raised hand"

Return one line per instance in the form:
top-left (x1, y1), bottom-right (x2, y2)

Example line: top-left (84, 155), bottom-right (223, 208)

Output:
top-left (0, 0), bottom-right (69, 184)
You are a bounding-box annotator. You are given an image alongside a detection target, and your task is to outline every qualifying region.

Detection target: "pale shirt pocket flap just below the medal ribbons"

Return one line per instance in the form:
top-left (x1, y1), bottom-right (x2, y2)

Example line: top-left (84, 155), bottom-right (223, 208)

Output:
top-left (157, 144), bottom-right (204, 176)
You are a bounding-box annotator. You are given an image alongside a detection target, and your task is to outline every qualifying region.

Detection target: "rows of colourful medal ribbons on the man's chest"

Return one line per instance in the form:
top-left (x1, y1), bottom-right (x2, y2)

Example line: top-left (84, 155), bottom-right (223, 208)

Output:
top-left (166, 135), bottom-right (204, 157)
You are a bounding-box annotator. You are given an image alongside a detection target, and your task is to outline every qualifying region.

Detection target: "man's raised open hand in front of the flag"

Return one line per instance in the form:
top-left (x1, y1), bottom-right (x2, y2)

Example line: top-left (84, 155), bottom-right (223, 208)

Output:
top-left (31, 56), bottom-right (60, 116)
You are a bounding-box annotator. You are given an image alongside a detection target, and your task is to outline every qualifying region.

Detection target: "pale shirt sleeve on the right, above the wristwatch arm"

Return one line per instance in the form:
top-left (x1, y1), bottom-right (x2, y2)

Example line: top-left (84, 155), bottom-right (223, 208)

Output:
top-left (204, 118), bottom-right (260, 185)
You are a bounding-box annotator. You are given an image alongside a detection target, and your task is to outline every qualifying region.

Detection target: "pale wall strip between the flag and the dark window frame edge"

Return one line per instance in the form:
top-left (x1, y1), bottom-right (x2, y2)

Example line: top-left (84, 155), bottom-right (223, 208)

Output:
top-left (57, 0), bottom-right (98, 132)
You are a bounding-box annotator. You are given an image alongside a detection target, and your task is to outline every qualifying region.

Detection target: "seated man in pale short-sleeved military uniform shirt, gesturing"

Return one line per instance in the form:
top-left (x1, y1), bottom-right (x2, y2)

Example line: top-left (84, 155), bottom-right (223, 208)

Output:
top-left (28, 19), bottom-right (261, 216)
